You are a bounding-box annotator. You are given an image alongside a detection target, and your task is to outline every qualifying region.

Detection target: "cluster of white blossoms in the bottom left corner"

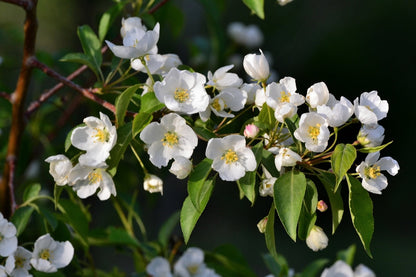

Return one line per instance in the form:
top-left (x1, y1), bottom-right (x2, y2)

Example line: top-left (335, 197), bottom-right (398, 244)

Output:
top-left (0, 213), bottom-right (74, 277)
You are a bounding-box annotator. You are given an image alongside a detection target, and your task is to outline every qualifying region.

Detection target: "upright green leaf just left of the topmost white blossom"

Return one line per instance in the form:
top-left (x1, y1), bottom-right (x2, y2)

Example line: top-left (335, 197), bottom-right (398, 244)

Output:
top-left (78, 25), bottom-right (103, 77)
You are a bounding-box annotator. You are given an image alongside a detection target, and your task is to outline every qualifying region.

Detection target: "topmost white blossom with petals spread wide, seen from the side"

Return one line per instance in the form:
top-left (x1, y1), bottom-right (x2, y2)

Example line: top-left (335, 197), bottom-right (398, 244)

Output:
top-left (105, 23), bottom-right (160, 59)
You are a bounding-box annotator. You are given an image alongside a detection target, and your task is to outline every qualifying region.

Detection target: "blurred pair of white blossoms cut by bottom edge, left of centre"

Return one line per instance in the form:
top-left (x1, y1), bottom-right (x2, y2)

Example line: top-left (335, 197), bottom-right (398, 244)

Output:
top-left (146, 247), bottom-right (220, 277)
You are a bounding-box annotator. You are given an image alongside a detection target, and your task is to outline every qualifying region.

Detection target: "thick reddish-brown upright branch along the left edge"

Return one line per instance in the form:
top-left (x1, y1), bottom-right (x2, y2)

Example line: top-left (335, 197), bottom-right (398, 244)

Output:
top-left (0, 0), bottom-right (38, 218)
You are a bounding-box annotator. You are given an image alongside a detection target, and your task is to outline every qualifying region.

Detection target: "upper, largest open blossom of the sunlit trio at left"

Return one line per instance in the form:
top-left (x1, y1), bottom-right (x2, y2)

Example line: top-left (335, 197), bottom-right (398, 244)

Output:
top-left (71, 112), bottom-right (117, 167)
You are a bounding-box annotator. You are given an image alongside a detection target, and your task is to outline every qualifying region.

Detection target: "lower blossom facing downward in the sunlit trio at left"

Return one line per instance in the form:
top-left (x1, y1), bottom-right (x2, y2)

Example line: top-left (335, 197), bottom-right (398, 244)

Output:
top-left (69, 164), bottom-right (117, 201)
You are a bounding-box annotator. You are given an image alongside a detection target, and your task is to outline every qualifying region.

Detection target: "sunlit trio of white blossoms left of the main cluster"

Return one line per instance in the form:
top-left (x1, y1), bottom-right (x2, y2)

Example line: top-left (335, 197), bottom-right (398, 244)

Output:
top-left (45, 113), bottom-right (117, 200)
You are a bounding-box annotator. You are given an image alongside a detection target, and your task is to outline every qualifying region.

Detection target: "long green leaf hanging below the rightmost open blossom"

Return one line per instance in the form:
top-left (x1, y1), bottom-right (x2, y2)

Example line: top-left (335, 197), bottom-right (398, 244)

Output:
top-left (347, 175), bottom-right (374, 257)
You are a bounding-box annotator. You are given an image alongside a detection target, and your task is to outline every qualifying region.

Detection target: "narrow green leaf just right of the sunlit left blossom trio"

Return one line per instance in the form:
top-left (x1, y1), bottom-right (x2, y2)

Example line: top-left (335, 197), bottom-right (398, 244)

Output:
top-left (107, 122), bottom-right (132, 176)
